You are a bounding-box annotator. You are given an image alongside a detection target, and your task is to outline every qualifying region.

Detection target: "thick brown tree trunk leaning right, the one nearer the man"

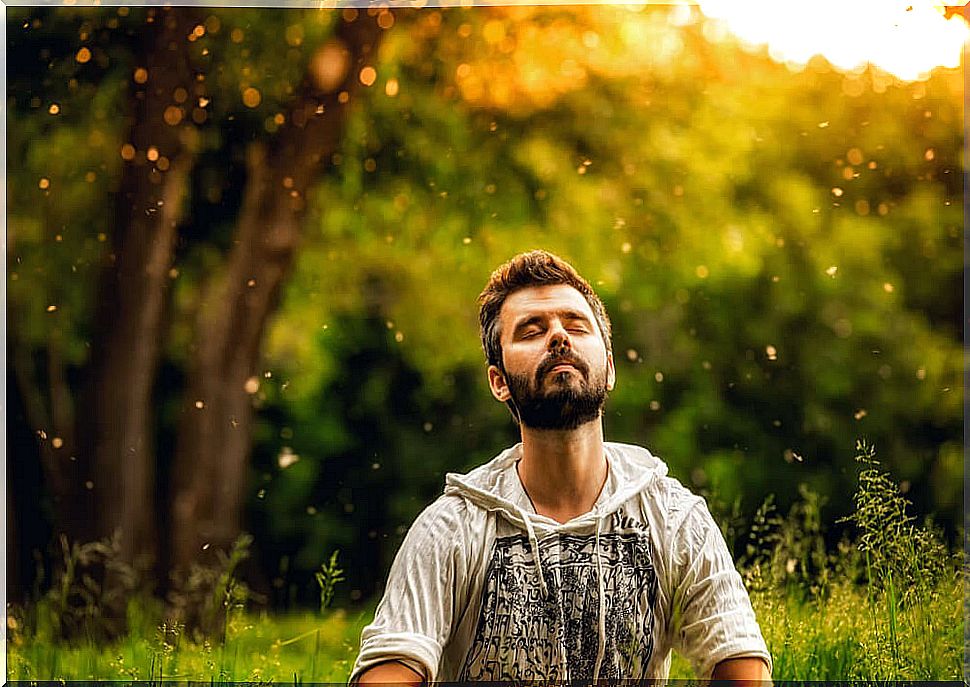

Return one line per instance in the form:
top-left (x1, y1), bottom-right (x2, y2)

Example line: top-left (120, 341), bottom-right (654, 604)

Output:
top-left (170, 10), bottom-right (387, 575)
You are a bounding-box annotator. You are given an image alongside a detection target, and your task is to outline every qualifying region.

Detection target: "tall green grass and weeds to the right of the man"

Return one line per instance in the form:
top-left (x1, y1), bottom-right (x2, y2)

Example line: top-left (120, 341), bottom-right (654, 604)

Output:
top-left (741, 440), bottom-right (963, 680)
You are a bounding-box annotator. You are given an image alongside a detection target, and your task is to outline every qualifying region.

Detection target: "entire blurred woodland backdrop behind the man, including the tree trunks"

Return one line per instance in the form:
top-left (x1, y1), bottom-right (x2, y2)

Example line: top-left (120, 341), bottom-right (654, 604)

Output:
top-left (6, 6), bottom-right (964, 608)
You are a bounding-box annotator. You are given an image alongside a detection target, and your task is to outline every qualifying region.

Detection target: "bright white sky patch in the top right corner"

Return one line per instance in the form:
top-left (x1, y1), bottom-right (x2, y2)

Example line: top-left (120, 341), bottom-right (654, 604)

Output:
top-left (697, 0), bottom-right (970, 81)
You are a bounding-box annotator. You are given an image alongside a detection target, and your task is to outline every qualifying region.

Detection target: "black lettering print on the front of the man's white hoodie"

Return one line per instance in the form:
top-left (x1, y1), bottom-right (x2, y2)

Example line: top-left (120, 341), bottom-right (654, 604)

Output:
top-left (459, 514), bottom-right (658, 682)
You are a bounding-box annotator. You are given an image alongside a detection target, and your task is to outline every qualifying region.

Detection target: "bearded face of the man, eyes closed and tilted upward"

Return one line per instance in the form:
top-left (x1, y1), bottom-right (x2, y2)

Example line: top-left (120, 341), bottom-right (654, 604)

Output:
top-left (488, 284), bottom-right (615, 430)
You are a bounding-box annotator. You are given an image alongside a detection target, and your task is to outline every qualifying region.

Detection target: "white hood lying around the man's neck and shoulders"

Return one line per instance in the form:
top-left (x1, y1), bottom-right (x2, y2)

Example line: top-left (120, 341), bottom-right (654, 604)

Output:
top-left (445, 442), bottom-right (667, 532)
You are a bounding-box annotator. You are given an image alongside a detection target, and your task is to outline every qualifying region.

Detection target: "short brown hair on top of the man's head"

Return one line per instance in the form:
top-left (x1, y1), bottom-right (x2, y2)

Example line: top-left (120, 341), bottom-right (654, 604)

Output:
top-left (478, 250), bottom-right (613, 370)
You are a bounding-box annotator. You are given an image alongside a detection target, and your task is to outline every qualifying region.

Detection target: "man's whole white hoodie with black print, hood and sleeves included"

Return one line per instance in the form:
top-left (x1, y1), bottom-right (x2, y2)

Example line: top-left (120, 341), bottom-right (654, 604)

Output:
top-left (351, 443), bottom-right (771, 682)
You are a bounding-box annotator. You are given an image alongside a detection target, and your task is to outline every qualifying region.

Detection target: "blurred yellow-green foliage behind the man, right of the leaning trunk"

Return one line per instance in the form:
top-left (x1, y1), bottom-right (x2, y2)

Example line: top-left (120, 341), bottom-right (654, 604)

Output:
top-left (255, 8), bottom-right (962, 596)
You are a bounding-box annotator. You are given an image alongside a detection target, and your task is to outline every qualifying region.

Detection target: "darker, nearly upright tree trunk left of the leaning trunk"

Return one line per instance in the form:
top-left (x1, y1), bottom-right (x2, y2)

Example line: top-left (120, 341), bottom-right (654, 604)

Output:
top-left (79, 8), bottom-right (201, 563)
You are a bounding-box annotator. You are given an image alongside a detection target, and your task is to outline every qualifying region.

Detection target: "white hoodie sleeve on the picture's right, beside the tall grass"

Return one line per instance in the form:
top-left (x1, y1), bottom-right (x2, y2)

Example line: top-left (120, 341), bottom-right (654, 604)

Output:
top-left (670, 490), bottom-right (771, 680)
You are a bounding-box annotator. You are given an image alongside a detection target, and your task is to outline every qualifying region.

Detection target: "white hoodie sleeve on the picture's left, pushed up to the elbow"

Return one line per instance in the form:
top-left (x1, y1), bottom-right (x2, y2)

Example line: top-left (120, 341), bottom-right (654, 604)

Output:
top-left (350, 497), bottom-right (467, 683)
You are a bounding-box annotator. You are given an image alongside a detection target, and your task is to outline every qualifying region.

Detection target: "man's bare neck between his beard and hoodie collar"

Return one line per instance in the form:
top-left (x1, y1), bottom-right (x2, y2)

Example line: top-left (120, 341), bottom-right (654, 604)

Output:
top-left (518, 418), bottom-right (608, 522)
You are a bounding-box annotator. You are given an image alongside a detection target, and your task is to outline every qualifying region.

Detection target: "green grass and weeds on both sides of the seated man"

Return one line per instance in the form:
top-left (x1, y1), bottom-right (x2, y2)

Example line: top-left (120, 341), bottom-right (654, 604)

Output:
top-left (7, 442), bottom-right (964, 684)
